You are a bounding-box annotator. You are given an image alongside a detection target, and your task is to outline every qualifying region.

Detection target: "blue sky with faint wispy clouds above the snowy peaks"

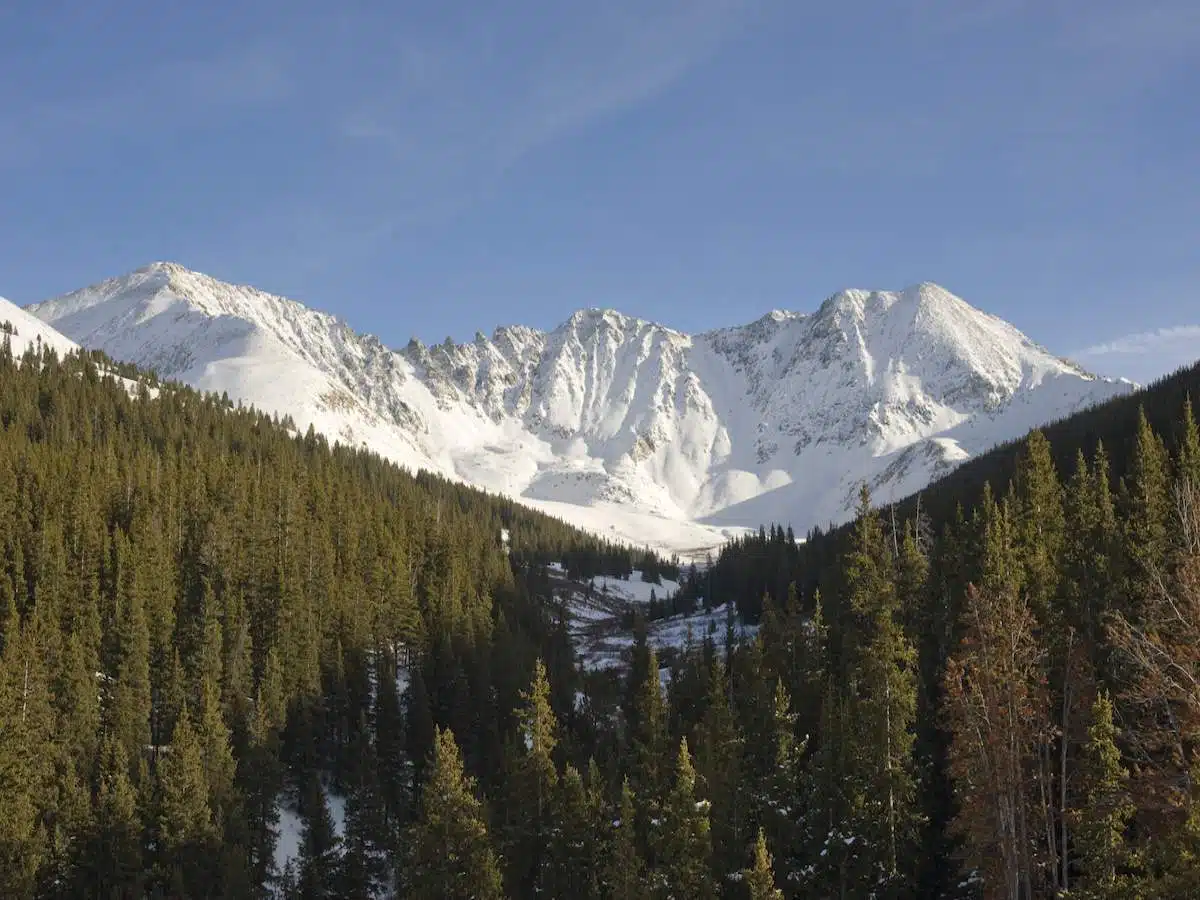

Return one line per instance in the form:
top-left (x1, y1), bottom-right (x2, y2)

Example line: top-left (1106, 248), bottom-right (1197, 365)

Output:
top-left (0, 0), bottom-right (1200, 379)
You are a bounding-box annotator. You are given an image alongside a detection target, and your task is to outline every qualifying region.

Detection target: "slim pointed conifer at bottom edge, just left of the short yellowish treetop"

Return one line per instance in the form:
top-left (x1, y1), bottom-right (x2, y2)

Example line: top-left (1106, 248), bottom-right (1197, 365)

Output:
top-left (654, 738), bottom-right (716, 900)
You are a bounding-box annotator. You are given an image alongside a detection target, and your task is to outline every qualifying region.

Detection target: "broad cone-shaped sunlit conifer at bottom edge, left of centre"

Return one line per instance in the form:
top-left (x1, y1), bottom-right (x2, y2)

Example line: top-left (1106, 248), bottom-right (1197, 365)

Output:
top-left (408, 728), bottom-right (503, 900)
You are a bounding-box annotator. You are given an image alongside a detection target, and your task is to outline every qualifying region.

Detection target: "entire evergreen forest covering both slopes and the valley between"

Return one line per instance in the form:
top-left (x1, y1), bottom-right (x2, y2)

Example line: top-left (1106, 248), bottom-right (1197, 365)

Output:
top-left (0, 338), bottom-right (1200, 900)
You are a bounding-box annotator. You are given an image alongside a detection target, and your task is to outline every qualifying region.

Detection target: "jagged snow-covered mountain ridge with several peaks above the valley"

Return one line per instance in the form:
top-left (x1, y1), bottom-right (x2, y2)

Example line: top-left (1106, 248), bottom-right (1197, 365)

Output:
top-left (29, 263), bottom-right (1133, 550)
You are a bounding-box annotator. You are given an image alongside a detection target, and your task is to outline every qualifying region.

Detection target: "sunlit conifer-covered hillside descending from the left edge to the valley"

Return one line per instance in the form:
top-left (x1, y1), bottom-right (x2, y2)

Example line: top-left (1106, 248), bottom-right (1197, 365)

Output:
top-left (0, 340), bottom-right (644, 898)
